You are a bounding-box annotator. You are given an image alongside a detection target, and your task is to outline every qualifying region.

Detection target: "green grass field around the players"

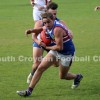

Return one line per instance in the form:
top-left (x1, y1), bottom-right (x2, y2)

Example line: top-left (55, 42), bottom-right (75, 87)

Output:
top-left (0, 0), bottom-right (100, 100)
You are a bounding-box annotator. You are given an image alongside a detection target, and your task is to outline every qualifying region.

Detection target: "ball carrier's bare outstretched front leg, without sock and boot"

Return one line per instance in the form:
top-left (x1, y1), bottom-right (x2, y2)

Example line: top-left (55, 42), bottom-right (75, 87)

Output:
top-left (29, 53), bottom-right (56, 88)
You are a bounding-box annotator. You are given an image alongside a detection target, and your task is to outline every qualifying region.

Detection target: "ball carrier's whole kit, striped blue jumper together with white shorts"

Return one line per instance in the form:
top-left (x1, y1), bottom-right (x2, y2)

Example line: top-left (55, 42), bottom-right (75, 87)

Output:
top-left (47, 20), bottom-right (75, 67)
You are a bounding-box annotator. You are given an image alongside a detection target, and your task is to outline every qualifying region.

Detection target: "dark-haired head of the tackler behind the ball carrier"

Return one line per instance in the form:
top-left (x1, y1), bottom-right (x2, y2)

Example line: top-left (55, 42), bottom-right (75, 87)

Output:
top-left (47, 2), bottom-right (58, 19)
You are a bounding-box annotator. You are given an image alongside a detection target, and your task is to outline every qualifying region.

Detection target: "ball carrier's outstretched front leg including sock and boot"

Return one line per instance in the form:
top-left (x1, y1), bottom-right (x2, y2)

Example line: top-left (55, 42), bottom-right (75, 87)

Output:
top-left (17, 53), bottom-right (55, 96)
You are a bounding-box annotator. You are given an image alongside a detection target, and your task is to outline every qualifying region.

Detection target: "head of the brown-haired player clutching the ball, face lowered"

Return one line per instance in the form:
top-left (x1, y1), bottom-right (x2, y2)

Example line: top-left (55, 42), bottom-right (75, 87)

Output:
top-left (41, 12), bottom-right (54, 29)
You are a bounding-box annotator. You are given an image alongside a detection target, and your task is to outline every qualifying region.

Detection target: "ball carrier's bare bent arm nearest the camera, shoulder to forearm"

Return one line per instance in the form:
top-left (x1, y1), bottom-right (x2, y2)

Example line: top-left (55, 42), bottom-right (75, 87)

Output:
top-left (46, 27), bottom-right (64, 51)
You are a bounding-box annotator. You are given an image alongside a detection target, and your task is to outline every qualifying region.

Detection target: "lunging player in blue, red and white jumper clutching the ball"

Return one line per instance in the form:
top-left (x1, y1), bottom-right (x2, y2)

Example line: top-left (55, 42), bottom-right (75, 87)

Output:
top-left (17, 13), bottom-right (83, 96)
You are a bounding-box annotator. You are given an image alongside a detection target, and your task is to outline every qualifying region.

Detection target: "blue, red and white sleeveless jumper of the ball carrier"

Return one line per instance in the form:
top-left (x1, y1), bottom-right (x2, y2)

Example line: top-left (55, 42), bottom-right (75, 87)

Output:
top-left (47, 20), bottom-right (75, 55)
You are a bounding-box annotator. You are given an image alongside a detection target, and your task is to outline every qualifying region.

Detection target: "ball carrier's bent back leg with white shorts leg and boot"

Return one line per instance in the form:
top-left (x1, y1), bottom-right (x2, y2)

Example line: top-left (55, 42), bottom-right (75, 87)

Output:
top-left (59, 55), bottom-right (83, 89)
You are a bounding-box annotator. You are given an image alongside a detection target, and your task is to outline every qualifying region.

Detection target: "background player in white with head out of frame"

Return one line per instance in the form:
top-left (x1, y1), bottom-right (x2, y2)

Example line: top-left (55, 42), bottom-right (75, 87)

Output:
top-left (30, 0), bottom-right (51, 22)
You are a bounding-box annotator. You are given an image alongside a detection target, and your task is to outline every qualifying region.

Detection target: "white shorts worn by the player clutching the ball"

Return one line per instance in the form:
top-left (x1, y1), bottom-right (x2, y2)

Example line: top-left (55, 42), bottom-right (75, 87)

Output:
top-left (49, 50), bottom-right (73, 67)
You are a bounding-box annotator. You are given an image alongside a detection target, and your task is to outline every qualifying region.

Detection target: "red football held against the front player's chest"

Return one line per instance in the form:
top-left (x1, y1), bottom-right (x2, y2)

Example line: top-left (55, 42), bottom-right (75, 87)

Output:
top-left (40, 30), bottom-right (51, 45)
